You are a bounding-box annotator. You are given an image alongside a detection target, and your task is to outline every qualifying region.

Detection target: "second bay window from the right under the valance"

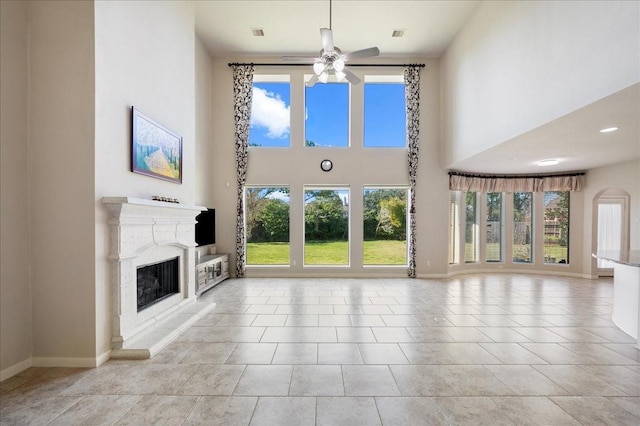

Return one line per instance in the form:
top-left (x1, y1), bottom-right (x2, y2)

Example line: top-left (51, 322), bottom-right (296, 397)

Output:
top-left (512, 192), bottom-right (533, 263)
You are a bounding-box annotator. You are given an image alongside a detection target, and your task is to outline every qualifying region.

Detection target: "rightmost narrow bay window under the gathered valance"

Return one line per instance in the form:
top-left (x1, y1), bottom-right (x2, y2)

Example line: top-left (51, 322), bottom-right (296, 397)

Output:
top-left (544, 191), bottom-right (570, 263)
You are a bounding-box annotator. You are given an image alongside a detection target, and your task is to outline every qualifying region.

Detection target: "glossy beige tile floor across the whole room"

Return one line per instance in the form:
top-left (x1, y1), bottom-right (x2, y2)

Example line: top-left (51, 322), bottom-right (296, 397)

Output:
top-left (0, 274), bottom-right (640, 426)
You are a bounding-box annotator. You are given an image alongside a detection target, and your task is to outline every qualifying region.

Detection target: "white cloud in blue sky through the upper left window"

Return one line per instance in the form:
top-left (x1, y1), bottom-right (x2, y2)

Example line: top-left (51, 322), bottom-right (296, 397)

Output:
top-left (251, 87), bottom-right (290, 139)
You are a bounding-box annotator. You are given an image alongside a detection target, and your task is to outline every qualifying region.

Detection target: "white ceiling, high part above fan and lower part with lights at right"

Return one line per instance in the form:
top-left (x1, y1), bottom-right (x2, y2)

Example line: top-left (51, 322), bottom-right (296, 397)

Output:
top-left (196, 0), bottom-right (640, 173)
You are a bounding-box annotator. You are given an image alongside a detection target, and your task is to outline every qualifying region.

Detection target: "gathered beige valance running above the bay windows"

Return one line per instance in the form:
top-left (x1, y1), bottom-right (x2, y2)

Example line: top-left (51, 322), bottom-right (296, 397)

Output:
top-left (449, 171), bottom-right (585, 193)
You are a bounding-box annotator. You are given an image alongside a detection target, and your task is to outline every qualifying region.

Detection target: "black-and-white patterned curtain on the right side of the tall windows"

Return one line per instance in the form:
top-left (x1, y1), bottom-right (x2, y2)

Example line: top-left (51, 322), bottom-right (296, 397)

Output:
top-left (404, 67), bottom-right (420, 278)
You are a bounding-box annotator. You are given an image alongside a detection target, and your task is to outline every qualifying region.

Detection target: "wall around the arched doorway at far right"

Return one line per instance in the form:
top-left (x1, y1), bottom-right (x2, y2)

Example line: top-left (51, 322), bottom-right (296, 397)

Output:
top-left (583, 160), bottom-right (640, 276)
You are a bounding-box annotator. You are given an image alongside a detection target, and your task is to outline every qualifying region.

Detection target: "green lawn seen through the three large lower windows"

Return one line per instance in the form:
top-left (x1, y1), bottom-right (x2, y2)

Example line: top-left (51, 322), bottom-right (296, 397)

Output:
top-left (247, 240), bottom-right (407, 265)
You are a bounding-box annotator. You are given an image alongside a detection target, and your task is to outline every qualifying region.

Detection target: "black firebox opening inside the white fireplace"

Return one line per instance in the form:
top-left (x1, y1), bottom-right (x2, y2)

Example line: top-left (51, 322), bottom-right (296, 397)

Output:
top-left (137, 257), bottom-right (180, 312)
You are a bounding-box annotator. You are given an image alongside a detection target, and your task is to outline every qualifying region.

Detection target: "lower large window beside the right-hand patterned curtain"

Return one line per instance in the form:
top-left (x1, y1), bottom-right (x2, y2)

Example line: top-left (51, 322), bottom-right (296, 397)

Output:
top-left (363, 188), bottom-right (408, 265)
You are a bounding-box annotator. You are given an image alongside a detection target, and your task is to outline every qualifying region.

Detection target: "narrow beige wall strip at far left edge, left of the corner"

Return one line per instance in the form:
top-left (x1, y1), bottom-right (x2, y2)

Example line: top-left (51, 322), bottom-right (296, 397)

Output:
top-left (0, 1), bottom-right (33, 380)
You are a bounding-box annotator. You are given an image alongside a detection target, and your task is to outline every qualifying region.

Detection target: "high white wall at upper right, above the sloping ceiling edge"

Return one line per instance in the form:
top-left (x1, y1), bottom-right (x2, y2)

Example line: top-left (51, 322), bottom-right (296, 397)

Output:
top-left (442, 1), bottom-right (640, 167)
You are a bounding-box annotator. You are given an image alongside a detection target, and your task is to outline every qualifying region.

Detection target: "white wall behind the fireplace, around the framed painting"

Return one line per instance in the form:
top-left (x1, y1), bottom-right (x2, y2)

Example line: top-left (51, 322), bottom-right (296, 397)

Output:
top-left (92, 1), bottom-right (196, 357)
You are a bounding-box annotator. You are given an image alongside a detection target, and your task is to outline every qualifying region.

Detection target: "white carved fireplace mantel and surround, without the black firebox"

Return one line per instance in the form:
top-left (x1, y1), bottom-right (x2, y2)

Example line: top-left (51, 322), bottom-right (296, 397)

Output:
top-left (102, 197), bottom-right (206, 351)
